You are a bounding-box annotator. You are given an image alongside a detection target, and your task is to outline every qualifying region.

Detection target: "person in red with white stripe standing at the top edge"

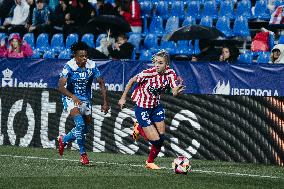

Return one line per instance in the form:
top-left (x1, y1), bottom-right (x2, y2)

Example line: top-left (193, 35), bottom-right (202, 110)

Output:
top-left (118, 0), bottom-right (142, 33)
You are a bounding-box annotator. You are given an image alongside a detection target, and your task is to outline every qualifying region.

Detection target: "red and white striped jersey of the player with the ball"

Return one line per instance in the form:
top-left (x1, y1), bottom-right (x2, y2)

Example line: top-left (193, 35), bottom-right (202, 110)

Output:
top-left (131, 67), bottom-right (177, 108)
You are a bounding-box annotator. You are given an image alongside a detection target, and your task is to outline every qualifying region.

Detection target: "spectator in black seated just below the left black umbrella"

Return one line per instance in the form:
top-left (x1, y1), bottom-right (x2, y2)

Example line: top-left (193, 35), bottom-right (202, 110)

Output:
top-left (108, 34), bottom-right (134, 59)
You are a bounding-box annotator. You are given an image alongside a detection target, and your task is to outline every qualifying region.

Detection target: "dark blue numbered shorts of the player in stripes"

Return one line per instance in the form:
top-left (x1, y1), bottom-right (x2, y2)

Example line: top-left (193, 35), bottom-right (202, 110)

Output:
top-left (134, 104), bottom-right (165, 127)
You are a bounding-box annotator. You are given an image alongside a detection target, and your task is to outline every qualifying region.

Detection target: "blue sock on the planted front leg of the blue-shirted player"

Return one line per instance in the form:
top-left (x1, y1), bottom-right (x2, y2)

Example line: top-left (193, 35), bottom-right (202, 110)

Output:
top-left (73, 115), bottom-right (86, 155)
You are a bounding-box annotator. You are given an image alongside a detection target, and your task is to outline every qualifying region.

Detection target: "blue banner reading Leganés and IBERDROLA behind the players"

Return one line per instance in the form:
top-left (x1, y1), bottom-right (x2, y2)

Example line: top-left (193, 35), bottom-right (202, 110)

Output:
top-left (0, 59), bottom-right (284, 96)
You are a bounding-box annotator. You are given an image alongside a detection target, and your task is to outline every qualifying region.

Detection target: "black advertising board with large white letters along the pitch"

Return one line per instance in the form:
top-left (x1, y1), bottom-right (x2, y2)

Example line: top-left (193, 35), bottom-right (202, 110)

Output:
top-left (0, 88), bottom-right (284, 166)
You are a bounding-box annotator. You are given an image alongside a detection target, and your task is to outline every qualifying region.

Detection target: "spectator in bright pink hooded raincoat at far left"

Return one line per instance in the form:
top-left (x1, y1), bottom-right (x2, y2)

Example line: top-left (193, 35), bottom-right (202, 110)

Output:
top-left (0, 34), bottom-right (33, 58)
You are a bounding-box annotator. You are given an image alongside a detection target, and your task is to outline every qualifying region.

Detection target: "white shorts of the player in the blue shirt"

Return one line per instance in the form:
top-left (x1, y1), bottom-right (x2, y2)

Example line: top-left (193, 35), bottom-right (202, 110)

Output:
top-left (63, 97), bottom-right (92, 115)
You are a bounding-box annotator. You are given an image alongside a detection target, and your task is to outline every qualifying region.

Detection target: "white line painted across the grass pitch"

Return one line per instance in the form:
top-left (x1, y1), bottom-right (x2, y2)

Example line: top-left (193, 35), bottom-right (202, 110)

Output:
top-left (0, 154), bottom-right (282, 179)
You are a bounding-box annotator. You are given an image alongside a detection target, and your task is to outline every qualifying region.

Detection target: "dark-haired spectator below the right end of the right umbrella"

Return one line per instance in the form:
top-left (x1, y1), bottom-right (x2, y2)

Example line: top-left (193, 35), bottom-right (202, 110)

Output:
top-left (219, 45), bottom-right (240, 62)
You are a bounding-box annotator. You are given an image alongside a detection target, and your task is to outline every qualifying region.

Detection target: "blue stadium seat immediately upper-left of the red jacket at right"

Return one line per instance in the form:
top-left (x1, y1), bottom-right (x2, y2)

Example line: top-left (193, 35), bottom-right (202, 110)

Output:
top-left (233, 16), bottom-right (250, 37)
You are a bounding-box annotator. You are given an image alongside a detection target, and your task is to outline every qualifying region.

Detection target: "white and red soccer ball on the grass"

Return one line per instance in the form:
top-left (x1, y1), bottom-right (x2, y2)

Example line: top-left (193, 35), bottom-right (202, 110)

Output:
top-left (172, 156), bottom-right (191, 175)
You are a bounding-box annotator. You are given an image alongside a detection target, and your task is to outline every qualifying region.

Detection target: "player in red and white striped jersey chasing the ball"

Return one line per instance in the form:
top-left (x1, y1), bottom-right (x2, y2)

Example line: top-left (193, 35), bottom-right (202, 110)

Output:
top-left (118, 50), bottom-right (185, 169)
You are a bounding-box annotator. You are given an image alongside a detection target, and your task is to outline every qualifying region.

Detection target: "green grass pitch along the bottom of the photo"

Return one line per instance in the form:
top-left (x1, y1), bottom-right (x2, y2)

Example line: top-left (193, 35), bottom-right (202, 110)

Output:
top-left (0, 146), bottom-right (284, 189)
